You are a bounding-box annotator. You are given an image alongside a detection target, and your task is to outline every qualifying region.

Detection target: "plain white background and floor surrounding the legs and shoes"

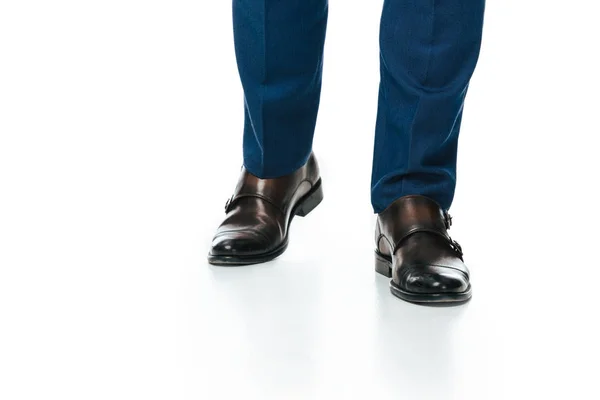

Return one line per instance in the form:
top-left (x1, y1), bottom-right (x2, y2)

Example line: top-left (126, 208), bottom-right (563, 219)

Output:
top-left (0, 0), bottom-right (600, 400)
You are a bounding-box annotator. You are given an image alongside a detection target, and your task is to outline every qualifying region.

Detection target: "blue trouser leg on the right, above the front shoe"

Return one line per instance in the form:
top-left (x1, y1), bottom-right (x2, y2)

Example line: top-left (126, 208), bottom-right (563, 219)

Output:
top-left (371, 0), bottom-right (484, 213)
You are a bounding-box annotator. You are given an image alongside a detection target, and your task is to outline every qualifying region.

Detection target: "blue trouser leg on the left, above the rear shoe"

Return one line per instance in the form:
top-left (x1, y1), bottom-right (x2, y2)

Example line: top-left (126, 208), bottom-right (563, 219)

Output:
top-left (233, 0), bottom-right (328, 178)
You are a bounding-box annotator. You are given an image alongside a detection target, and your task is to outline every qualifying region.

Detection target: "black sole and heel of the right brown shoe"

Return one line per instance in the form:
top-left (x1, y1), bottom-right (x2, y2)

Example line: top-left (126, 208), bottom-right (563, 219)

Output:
top-left (375, 250), bottom-right (472, 306)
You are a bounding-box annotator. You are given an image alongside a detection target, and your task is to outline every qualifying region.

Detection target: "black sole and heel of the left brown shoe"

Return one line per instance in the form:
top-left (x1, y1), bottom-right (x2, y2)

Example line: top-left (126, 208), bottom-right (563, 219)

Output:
top-left (208, 178), bottom-right (323, 267)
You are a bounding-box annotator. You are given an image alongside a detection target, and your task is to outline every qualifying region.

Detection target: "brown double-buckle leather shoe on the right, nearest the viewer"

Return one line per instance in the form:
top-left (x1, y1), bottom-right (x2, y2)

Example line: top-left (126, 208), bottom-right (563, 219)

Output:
top-left (375, 196), bottom-right (471, 303)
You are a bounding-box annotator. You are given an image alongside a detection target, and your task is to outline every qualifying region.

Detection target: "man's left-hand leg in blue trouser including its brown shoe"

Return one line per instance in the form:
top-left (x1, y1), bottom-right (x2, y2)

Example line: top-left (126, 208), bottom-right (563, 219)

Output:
top-left (208, 0), bottom-right (328, 265)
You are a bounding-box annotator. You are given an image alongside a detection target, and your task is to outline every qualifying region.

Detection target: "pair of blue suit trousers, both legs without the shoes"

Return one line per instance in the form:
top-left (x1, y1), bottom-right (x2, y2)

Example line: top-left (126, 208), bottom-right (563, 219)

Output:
top-left (233, 0), bottom-right (485, 213)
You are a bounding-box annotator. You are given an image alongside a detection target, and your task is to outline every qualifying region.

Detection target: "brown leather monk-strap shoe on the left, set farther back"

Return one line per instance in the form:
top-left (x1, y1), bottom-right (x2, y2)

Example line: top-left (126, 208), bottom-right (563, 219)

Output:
top-left (208, 154), bottom-right (323, 265)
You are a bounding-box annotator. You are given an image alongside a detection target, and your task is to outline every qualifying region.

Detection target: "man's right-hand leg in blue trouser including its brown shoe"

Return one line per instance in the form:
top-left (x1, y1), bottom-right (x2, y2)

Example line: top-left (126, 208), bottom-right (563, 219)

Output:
top-left (371, 0), bottom-right (484, 302)
